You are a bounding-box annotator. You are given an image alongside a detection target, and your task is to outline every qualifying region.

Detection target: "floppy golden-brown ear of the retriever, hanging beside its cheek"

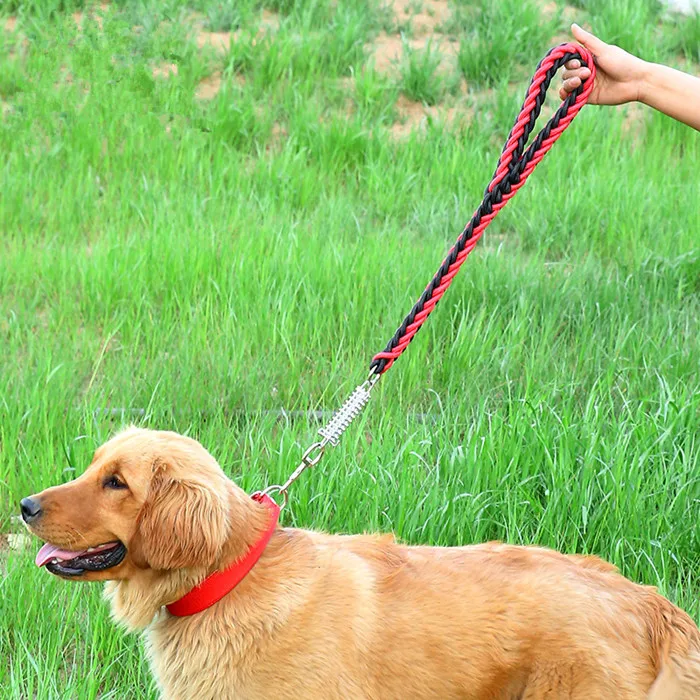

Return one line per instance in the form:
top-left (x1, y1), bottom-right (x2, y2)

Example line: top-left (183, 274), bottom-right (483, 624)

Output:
top-left (129, 470), bottom-right (229, 570)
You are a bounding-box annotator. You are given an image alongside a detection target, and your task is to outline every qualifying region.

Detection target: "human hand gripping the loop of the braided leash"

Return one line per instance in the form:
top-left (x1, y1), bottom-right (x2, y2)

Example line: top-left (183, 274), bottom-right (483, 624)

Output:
top-left (559, 24), bottom-right (648, 105)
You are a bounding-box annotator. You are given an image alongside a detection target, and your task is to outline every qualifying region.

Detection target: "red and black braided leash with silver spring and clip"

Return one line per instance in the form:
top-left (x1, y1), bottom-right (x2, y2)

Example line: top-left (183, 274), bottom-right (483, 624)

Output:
top-left (264, 43), bottom-right (596, 504)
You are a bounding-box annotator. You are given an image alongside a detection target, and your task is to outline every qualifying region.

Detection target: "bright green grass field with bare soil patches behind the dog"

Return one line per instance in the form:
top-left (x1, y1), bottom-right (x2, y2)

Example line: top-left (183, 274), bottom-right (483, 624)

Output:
top-left (0, 0), bottom-right (700, 699)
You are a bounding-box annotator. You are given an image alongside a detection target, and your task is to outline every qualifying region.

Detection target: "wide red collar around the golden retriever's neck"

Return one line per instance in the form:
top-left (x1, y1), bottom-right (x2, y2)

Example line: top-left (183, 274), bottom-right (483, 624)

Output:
top-left (165, 493), bottom-right (280, 617)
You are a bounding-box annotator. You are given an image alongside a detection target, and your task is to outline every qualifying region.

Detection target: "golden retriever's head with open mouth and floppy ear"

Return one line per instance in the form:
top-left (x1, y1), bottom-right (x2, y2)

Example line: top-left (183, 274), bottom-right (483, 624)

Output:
top-left (21, 428), bottom-right (238, 581)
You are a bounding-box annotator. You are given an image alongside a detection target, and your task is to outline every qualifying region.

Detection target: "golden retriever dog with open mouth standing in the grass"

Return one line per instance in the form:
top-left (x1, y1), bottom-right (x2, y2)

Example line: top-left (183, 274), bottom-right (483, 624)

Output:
top-left (21, 428), bottom-right (700, 700)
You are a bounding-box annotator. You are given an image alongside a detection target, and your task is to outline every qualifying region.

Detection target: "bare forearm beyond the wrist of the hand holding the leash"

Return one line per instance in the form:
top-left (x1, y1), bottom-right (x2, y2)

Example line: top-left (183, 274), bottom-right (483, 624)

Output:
top-left (639, 63), bottom-right (700, 131)
